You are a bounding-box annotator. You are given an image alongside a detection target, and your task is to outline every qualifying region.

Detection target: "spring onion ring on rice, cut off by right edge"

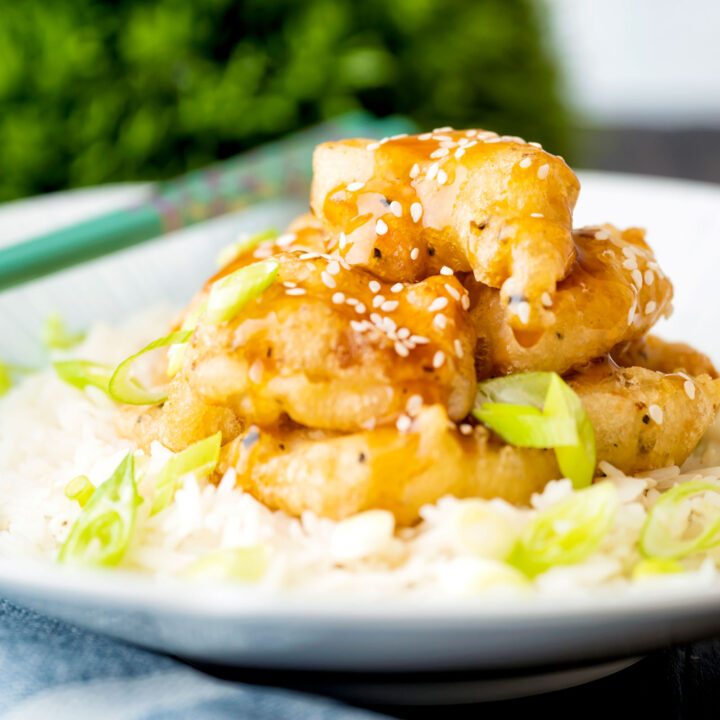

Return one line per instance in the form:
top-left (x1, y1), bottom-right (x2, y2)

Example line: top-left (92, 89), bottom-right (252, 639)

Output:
top-left (639, 480), bottom-right (720, 559)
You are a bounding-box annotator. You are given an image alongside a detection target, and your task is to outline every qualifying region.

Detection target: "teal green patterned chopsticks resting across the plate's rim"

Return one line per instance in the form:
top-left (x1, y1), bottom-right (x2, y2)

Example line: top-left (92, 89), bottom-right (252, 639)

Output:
top-left (0, 112), bottom-right (412, 290)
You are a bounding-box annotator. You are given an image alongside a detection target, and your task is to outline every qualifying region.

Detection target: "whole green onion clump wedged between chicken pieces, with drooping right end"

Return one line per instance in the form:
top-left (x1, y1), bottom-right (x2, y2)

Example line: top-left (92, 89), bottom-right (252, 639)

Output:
top-left (473, 372), bottom-right (595, 488)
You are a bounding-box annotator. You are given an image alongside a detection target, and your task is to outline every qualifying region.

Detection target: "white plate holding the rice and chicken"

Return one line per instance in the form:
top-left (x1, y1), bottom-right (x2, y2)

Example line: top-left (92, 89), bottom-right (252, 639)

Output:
top-left (0, 173), bottom-right (720, 696)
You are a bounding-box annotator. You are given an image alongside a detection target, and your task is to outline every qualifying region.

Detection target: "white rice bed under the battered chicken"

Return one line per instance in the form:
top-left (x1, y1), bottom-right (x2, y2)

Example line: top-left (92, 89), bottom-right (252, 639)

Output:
top-left (0, 310), bottom-right (720, 598)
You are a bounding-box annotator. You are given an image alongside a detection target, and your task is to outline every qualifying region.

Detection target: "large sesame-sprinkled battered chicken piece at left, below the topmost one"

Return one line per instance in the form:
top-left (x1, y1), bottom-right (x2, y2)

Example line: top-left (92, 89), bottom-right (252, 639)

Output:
top-left (150, 253), bottom-right (476, 449)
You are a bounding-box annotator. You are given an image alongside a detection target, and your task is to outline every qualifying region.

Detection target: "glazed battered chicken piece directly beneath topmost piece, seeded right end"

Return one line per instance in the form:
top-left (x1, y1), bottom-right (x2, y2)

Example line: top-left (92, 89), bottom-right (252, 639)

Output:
top-left (465, 225), bottom-right (673, 376)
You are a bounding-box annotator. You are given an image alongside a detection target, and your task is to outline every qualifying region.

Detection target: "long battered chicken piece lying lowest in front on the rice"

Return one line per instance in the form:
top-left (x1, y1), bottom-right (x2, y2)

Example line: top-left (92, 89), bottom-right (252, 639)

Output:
top-left (221, 405), bottom-right (559, 525)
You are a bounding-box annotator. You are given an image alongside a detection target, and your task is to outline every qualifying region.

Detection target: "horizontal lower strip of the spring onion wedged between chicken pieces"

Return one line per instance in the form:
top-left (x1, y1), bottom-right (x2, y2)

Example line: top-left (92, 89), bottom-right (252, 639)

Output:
top-left (474, 403), bottom-right (578, 448)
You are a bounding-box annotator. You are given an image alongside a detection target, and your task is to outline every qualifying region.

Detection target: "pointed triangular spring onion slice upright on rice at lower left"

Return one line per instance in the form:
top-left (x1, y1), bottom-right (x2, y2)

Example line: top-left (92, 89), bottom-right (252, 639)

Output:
top-left (58, 453), bottom-right (140, 567)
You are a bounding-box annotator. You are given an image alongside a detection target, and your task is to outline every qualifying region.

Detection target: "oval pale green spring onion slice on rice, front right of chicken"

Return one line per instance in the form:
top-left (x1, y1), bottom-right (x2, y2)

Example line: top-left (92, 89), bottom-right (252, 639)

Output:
top-left (508, 482), bottom-right (618, 577)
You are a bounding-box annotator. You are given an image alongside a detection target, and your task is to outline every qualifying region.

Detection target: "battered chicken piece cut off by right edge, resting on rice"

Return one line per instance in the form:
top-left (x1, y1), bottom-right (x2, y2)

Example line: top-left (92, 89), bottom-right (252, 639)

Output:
top-left (567, 359), bottom-right (720, 474)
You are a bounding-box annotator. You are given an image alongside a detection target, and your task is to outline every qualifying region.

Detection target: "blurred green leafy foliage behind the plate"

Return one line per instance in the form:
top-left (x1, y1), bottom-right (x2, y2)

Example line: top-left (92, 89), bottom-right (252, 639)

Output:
top-left (0, 0), bottom-right (566, 200)
